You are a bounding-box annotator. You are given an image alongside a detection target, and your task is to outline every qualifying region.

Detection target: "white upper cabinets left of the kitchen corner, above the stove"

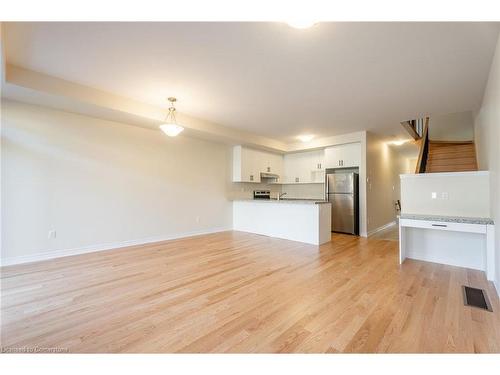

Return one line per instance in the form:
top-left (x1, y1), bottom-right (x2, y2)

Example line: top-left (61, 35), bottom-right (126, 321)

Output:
top-left (233, 146), bottom-right (283, 182)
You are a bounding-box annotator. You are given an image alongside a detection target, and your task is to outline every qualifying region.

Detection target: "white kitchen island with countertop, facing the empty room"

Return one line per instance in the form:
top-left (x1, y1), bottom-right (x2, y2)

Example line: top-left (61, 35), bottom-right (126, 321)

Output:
top-left (233, 199), bottom-right (331, 245)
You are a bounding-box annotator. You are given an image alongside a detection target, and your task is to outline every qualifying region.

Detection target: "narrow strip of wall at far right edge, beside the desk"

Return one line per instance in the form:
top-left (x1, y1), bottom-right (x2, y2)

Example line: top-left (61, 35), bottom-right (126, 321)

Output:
top-left (474, 33), bottom-right (500, 293)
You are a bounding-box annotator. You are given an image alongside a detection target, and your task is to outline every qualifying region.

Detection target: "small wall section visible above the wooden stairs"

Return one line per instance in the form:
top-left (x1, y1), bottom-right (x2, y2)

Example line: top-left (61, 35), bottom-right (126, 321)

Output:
top-left (429, 111), bottom-right (474, 141)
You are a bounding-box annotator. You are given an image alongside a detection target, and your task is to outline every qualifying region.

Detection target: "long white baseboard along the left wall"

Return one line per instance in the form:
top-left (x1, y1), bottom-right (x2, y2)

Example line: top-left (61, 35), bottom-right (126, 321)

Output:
top-left (0, 227), bottom-right (232, 267)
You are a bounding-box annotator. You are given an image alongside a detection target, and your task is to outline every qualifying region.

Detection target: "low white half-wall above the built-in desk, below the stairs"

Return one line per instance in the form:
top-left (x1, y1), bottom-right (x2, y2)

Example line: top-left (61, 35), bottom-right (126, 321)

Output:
top-left (401, 172), bottom-right (490, 217)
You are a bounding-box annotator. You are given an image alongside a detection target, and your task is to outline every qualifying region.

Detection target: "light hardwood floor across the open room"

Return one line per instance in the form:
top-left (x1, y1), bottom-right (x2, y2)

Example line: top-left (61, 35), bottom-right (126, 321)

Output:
top-left (1, 232), bottom-right (500, 353)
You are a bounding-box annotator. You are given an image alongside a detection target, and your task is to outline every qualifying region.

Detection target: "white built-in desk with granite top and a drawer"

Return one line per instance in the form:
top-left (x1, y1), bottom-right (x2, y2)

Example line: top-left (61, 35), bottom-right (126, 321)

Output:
top-left (399, 214), bottom-right (495, 280)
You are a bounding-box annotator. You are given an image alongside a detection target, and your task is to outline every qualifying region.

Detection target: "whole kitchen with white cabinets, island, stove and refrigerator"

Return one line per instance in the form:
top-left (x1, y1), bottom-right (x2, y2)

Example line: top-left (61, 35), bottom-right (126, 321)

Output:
top-left (232, 142), bottom-right (364, 245)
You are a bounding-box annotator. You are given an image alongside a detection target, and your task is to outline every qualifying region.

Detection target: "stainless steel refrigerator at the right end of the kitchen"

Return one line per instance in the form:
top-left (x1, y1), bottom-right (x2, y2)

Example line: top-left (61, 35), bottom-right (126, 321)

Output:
top-left (326, 171), bottom-right (359, 235)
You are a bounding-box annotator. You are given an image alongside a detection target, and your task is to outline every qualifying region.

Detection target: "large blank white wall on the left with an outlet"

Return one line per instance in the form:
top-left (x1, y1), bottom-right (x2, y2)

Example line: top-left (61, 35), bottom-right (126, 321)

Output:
top-left (1, 101), bottom-right (235, 262)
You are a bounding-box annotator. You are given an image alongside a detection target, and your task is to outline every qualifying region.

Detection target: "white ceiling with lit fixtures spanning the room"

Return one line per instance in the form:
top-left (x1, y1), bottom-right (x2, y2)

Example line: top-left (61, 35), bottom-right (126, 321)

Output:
top-left (4, 23), bottom-right (500, 142)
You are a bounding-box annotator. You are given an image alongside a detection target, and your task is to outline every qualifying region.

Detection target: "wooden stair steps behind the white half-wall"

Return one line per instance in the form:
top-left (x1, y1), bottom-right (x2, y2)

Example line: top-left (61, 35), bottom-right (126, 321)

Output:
top-left (425, 140), bottom-right (477, 173)
